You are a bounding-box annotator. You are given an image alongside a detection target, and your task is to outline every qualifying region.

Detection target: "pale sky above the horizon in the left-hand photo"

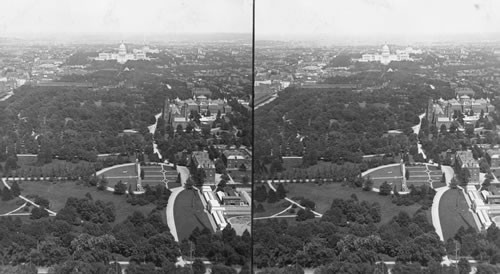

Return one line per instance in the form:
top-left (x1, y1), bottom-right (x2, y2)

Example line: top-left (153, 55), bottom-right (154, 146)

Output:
top-left (0, 0), bottom-right (252, 36)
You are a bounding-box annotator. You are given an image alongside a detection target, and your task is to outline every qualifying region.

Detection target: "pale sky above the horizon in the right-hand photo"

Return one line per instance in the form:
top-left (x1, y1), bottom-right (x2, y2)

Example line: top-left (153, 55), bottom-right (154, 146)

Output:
top-left (255, 0), bottom-right (500, 39)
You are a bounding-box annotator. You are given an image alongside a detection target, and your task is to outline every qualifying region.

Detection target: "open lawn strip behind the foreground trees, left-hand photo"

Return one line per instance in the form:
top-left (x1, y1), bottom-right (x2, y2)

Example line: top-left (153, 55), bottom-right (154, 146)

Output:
top-left (14, 181), bottom-right (156, 223)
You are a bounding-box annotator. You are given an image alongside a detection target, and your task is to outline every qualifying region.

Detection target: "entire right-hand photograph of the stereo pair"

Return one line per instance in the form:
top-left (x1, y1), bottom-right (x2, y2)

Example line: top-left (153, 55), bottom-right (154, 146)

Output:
top-left (252, 0), bottom-right (500, 274)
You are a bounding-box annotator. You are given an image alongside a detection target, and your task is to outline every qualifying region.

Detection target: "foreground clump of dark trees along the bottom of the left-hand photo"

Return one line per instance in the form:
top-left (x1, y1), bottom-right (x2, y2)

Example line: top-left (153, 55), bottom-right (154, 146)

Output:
top-left (0, 194), bottom-right (186, 273)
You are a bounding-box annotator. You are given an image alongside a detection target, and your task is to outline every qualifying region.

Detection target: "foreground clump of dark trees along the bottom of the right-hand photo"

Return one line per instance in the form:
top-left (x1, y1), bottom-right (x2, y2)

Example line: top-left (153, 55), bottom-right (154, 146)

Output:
top-left (253, 199), bottom-right (446, 273)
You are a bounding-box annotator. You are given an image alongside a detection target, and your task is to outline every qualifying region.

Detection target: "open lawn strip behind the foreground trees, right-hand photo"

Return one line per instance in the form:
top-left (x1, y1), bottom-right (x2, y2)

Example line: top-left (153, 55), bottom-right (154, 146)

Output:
top-left (285, 183), bottom-right (420, 224)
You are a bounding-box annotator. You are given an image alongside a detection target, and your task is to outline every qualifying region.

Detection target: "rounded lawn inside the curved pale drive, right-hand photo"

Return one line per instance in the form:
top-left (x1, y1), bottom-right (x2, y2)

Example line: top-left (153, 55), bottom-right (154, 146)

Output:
top-left (439, 189), bottom-right (477, 241)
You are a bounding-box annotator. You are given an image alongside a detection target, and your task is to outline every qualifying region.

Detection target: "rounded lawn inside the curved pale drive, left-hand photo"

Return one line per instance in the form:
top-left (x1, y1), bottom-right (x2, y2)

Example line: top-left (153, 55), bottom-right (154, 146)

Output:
top-left (174, 190), bottom-right (212, 241)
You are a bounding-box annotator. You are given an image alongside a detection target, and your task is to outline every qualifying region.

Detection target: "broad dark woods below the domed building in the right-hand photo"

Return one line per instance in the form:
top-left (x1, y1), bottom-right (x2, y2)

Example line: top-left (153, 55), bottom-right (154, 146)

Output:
top-left (255, 76), bottom-right (453, 176)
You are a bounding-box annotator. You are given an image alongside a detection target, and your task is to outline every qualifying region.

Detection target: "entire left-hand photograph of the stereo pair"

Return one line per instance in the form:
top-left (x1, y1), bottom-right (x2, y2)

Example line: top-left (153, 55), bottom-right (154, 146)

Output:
top-left (0, 0), bottom-right (253, 274)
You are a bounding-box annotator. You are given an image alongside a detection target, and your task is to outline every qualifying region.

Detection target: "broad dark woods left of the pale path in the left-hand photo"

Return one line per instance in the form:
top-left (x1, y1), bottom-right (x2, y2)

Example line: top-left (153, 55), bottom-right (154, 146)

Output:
top-left (0, 86), bottom-right (159, 164)
